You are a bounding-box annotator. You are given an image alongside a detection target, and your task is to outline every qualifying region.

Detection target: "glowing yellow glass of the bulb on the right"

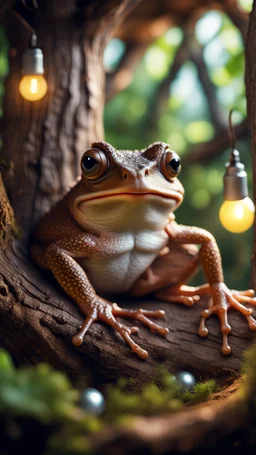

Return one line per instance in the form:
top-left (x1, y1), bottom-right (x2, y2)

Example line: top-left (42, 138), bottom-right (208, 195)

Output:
top-left (219, 197), bottom-right (255, 234)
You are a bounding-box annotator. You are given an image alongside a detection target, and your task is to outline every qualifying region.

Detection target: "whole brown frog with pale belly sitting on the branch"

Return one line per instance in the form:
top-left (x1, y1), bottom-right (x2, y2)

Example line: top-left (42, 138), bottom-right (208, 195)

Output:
top-left (30, 141), bottom-right (256, 359)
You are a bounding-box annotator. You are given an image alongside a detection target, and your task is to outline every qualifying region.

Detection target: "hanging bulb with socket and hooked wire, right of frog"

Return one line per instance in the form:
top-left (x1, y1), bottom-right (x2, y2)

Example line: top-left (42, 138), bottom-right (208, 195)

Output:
top-left (219, 111), bottom-right (255, 234)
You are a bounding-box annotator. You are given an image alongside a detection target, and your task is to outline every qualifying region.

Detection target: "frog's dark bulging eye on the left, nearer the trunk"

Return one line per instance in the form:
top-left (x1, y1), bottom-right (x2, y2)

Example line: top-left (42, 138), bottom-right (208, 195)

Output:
top-left (81, 149), bottom-right (108, 180)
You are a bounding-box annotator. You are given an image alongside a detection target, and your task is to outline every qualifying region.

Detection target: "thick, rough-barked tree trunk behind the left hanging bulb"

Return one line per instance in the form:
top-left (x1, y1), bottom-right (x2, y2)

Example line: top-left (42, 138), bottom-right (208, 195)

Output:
top-left (2, 0), bottom-right (138, 236)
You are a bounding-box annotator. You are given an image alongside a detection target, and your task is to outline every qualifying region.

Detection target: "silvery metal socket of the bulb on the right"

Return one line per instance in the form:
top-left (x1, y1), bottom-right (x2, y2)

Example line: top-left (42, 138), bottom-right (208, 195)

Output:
top-left (224, 150), bottom-right (248, 201)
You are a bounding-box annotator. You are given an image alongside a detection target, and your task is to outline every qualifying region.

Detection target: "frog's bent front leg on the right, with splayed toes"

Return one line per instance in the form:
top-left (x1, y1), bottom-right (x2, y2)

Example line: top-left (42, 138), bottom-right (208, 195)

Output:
top-left (158, 222), bottom-right (256, 355)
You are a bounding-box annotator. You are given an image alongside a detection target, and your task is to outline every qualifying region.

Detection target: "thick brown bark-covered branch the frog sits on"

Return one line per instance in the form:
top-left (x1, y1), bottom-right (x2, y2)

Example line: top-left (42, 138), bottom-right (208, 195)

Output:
top-left (0, 235), bottom-right (253, 386)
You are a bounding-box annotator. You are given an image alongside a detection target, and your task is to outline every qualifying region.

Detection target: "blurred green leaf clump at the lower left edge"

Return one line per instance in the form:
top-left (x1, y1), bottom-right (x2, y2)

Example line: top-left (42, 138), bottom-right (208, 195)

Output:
top-left (0, 350), bottom-right (78, 423)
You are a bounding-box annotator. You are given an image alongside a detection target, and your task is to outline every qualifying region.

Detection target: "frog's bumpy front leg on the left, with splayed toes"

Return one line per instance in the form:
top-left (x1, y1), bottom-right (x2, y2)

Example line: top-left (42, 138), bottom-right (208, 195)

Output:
top-left (34, 234), bottom-right (168, 359)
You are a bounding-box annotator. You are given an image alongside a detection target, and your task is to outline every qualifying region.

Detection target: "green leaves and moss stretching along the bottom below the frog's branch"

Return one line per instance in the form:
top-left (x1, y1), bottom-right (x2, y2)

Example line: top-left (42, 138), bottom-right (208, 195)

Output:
top-left (0, 349), bottom-right (218, 455)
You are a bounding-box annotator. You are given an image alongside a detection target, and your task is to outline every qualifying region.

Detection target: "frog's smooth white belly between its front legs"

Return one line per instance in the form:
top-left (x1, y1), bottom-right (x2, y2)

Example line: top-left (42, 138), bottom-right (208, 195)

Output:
top-left (79, 231), bottom-right (168, 294)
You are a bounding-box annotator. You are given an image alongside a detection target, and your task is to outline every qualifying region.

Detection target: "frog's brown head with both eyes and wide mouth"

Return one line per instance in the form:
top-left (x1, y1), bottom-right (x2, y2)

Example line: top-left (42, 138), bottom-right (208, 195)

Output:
top-left (72, 142), bottom-right (184, 233)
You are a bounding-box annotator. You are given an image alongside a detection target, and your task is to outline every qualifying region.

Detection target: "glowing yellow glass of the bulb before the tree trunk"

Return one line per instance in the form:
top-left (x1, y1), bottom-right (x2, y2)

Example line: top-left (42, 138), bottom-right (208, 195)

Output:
top-left (19, 74), bottom-right (47, 101)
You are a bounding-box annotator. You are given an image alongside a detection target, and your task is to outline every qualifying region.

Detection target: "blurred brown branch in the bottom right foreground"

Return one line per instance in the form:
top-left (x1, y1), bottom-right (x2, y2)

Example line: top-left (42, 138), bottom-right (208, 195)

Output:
top-left (92, 380), bottom-right (251, 455)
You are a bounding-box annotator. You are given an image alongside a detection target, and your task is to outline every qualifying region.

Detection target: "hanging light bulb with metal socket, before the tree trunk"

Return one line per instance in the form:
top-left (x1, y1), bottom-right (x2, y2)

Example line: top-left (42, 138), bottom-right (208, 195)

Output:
top-left (19, 33), bottom-right (47, 101)
